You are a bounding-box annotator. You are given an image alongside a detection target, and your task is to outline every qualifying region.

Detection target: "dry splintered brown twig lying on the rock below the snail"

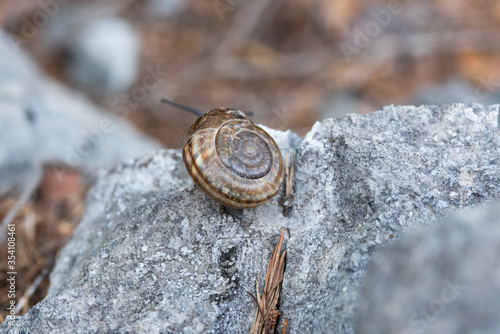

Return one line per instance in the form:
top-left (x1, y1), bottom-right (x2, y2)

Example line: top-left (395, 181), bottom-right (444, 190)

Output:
top-left (248, 227), bottom-right (288, 334)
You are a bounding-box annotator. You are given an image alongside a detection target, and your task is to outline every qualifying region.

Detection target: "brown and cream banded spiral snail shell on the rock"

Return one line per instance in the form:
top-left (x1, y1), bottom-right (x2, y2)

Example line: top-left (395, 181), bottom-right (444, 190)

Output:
top-left (182, 108), bottom-right (283, 209)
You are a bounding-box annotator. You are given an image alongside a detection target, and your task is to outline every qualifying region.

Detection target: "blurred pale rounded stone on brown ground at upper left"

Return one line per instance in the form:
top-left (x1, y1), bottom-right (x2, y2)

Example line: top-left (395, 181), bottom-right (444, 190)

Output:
top-left (43, 5), bottom-right (140, 99)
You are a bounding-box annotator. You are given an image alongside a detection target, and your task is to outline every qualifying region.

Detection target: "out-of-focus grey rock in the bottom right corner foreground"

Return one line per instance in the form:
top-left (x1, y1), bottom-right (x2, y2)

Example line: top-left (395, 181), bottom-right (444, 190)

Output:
top-left (356, 203), bottom-right (500, 334)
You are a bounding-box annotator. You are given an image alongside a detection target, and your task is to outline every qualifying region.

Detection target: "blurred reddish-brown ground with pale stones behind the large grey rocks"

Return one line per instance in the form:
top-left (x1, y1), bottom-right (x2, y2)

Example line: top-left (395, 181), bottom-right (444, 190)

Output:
top-left (0, 0), bottom-right (500, 320)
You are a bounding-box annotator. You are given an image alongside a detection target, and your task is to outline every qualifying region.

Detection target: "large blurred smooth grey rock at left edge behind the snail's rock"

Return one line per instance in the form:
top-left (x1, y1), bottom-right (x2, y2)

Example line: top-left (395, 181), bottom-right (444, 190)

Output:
top-left (0, 31), bottom-right (159, 194)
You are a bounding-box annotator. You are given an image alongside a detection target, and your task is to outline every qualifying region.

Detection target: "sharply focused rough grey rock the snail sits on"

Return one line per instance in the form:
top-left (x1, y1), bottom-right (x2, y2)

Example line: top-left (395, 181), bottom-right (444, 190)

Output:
top-left (0, 104), bottom-right (500, 333)
